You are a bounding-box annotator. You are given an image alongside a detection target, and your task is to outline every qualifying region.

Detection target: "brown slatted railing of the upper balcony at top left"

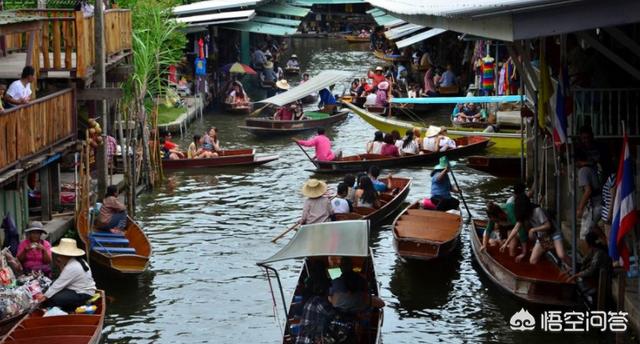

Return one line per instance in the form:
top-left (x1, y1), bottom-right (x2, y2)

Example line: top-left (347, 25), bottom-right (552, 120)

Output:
top-left (9, 9), bottom-right (132, 78)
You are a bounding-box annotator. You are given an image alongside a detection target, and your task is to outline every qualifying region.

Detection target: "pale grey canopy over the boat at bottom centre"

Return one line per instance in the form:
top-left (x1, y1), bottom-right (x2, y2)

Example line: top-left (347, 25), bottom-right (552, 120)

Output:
top-left (258, 220), bottom-right (369, 265)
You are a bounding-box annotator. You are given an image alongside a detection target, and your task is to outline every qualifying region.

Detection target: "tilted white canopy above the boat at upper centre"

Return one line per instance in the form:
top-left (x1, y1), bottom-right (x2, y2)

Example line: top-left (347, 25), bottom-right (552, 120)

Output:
top-left (257, 70), bottom-right (352, 106)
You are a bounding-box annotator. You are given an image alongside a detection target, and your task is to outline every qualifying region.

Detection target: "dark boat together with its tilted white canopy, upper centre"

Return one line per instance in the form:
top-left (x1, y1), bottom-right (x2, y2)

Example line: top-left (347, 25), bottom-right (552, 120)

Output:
top-left (238, 70), bottom-right (351, 136)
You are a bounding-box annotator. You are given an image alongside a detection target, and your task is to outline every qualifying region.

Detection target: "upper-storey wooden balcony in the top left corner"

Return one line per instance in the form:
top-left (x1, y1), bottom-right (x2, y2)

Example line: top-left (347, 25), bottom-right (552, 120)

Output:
top-left (0, 9), bottom-right (133, 79)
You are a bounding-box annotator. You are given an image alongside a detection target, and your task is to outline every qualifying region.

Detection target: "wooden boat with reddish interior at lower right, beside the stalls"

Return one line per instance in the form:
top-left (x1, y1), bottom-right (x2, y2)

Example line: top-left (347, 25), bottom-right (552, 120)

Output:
top-left (470, 220), bottom-right (579, 306)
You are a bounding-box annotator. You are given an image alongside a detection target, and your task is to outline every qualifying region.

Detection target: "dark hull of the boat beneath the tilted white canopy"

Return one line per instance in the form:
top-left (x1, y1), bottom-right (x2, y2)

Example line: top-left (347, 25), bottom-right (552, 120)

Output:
top-left (238, 110), bottom-right (349, 136)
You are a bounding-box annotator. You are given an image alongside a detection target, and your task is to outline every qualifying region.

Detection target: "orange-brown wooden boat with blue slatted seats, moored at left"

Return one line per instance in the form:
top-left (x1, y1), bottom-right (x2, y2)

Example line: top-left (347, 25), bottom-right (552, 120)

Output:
top-left (76, 211), bottom-right (152, 276)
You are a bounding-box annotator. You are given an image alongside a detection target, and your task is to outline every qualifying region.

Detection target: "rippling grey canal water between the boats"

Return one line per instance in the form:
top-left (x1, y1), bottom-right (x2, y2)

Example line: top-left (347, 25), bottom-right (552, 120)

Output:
top-left (98, 39), bottom-right (632, 344)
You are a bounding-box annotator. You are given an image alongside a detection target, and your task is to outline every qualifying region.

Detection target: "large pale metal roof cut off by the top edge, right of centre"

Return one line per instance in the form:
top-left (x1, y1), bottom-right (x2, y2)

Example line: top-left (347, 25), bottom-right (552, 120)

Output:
top-left (368, 0), bottom-right (584, 18)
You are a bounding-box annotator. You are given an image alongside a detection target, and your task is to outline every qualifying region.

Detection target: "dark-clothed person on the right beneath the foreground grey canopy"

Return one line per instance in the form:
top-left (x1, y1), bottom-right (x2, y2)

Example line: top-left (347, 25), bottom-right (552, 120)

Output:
top-left (329, 257), bottom-right (384, 315)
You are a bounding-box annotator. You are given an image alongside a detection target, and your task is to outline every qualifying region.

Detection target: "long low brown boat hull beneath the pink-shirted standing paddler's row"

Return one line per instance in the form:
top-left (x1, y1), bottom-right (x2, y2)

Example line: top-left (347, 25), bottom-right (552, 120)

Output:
top-left (313, 136), bottom-right (489, 173)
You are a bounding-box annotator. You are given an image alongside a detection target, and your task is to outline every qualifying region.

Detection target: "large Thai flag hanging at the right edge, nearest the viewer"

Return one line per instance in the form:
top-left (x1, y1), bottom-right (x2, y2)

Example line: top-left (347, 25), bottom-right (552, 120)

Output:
top-left (609, 133), bottom-right (637, 271)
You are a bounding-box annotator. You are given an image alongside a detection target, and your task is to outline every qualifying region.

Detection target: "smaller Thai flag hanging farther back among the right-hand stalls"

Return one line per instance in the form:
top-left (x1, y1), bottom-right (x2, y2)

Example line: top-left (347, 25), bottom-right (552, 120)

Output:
top-left (550, 66), bottom-right (573, 145)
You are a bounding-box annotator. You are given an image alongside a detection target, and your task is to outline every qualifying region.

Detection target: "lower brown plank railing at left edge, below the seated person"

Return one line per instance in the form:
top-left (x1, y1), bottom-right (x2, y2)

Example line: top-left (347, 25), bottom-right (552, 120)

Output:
top-left (0, 89), bottom-right (77, 172)
